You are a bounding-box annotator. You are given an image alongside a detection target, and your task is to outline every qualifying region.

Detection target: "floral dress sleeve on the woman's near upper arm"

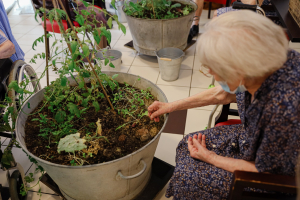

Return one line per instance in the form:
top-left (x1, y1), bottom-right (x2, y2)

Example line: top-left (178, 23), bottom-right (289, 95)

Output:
top-left (255, 89), bottom-right (300, 175)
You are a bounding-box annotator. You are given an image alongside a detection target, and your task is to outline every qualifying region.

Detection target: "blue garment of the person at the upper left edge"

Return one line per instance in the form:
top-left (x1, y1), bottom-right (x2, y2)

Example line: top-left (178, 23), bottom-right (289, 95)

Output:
top-left (0, 0), bottom-right (25, 62)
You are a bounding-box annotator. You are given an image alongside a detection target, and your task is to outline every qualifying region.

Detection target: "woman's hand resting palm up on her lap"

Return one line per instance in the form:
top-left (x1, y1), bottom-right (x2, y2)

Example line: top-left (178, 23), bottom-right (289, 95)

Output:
top-left (188, 133), bottom-right (215, 163)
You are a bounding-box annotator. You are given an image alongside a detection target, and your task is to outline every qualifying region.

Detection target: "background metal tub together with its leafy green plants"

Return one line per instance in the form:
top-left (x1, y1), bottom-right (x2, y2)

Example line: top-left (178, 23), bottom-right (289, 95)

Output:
top-left (123, 0), bottom-right (197, 56)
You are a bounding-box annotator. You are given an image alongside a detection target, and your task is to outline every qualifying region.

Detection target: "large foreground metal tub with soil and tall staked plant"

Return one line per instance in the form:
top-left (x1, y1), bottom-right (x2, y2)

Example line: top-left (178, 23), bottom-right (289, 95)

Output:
top-left (3, 0), bottom-right (167, 200)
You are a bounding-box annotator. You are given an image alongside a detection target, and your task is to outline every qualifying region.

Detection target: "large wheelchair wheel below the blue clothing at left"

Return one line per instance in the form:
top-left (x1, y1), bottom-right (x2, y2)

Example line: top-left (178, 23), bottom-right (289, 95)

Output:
top-left (7, 60), bottom-right (41, 113)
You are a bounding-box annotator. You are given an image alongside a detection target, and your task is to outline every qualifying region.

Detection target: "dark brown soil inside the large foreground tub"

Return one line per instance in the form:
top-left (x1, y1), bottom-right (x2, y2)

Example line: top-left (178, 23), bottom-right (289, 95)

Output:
top-left (25, 83), bottom-right (164, 165)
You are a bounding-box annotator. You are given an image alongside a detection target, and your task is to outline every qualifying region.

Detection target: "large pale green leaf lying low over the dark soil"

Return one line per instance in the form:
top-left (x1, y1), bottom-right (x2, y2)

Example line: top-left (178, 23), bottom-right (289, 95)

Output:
top-left (57, 133), bottom-right (87, 153)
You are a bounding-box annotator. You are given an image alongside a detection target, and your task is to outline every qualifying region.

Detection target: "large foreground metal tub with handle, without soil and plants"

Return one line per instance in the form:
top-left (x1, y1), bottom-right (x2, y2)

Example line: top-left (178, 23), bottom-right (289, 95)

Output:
top-left (16, 72), bottom-right (168, 200)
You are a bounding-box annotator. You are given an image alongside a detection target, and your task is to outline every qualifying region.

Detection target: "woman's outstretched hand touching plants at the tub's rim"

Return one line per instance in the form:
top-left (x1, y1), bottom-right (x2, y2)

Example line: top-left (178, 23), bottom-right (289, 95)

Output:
top-left (148, 101), bottom-right (173, 122)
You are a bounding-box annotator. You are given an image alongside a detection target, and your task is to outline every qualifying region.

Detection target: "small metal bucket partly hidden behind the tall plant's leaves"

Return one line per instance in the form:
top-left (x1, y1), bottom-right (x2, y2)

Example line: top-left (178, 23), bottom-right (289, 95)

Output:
top-left (95, 49), bottom-right (122, 72)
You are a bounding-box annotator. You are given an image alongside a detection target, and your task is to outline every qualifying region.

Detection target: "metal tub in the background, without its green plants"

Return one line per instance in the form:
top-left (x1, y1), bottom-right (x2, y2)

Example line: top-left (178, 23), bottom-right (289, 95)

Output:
top-left (123, 0), bottom-right (197, 56)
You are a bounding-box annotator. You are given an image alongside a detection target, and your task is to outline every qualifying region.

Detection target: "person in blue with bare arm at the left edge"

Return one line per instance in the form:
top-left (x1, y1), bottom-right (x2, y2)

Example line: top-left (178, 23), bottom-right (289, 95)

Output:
top-left (0, 0), bottom-right (25, 61)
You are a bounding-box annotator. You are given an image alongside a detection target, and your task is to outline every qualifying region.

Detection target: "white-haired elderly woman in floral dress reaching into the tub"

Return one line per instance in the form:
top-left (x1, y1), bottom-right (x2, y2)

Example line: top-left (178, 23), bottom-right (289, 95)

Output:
top-left (148, 11), bottom-right (300, 200)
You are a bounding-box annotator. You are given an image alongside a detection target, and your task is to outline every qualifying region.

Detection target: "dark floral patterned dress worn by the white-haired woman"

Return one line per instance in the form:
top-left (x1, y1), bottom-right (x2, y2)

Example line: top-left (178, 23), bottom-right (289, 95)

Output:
top-left (166, 50), bottom-right (300, 200)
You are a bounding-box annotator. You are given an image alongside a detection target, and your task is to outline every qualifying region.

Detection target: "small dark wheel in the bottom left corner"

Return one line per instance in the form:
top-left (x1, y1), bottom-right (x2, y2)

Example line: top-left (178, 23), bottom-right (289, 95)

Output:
top-left (8, 170), bottom-right (26, 200)
